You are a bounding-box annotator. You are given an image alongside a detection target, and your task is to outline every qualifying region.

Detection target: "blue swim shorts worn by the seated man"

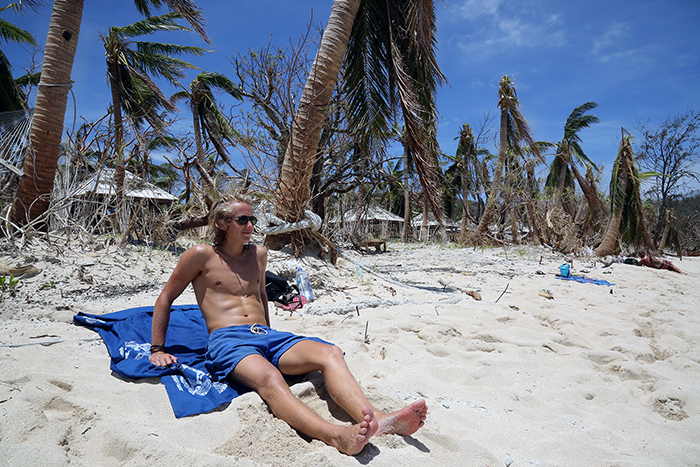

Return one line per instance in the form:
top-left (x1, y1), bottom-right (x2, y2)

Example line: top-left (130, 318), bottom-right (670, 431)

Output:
top-left (205, 324), bottom-right (333, 381)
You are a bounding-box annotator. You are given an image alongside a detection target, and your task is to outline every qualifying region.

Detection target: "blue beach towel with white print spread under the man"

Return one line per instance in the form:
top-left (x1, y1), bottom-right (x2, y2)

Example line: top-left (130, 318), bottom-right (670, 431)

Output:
top-left (73, 305), bottom-right (250, 418)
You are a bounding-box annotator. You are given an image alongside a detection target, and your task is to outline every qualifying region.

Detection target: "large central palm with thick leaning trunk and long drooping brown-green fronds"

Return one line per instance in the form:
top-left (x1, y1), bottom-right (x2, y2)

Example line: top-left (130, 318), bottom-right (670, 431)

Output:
top-left (278, 0), bottom-right (444, 254)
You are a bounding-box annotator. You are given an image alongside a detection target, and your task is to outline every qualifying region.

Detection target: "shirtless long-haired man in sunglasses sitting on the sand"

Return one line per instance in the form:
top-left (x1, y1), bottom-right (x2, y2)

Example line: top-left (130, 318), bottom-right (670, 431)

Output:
top-left (150, 194), bottom-right (428, 455)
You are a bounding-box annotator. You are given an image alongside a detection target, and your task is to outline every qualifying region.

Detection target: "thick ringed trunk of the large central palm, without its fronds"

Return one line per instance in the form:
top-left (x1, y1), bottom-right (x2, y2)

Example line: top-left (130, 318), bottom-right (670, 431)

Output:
top-left (278, 0), bottom-right (361, 254)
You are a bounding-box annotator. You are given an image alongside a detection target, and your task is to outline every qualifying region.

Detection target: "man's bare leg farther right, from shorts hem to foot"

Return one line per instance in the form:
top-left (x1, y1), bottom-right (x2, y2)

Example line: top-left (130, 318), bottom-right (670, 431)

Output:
top-left (279, 340), bottom-right (428, 436)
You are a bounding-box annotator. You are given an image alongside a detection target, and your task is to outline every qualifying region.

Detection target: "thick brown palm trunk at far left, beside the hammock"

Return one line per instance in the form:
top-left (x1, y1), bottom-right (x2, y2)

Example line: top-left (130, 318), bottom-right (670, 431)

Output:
top-left (10, 0), bottom-right (83, 229)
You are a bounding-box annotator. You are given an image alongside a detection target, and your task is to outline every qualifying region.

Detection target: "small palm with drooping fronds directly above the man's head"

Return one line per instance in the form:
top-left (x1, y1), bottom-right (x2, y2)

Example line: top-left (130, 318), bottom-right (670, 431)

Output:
top-left (170, 72), bottom-right (241, 204)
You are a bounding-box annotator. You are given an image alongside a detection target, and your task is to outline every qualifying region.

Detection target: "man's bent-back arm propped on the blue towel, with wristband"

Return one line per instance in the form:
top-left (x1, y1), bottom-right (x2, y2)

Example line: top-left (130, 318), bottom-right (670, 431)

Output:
top-left (149, 245), bottom-right (211, 367)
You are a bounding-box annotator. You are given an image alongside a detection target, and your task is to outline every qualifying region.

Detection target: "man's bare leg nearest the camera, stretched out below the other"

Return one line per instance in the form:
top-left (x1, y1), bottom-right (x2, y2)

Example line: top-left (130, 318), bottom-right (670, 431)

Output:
top-left (232, 355), bottom-right (378, 455)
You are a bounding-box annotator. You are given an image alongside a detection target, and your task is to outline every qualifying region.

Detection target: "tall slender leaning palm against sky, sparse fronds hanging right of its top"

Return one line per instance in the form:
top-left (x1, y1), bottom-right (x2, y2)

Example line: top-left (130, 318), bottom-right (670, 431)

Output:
top-left (474, 76), bottom-right (541, 239)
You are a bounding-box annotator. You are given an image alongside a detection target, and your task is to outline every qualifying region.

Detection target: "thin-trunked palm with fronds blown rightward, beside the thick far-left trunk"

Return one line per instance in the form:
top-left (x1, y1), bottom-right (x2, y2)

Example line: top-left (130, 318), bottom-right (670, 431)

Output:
top-left (100, 13), bottom-right (204, 228)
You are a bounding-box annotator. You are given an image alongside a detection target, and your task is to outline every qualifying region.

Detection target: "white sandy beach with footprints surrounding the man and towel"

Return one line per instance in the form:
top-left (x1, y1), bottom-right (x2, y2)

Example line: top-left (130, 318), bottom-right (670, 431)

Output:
top-left (0, 243), bottom-right (700, 467)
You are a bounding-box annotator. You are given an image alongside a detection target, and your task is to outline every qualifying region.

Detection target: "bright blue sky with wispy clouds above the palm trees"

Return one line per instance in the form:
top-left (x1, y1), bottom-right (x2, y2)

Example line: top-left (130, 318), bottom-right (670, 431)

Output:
top-left (2, 0), bottom-right (700, 188)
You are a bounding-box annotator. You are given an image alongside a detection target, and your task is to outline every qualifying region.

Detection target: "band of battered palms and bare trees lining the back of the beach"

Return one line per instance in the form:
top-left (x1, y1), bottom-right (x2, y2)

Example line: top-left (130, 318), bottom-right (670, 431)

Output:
top-left (0, 0), bottom-right (700, 257)
